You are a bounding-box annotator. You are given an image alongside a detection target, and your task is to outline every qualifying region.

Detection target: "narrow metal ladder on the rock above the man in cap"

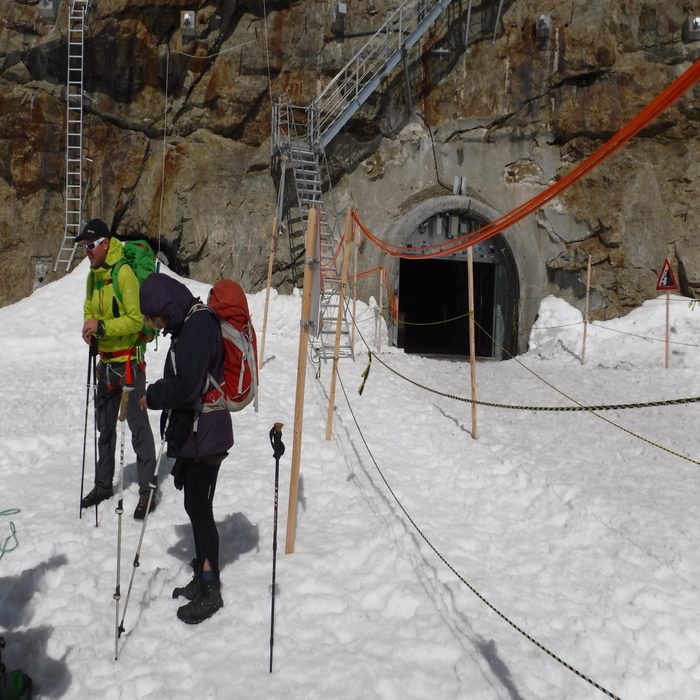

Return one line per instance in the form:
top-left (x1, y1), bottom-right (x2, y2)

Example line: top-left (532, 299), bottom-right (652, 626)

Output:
top-left (53, 0), bottom-right (90, 271)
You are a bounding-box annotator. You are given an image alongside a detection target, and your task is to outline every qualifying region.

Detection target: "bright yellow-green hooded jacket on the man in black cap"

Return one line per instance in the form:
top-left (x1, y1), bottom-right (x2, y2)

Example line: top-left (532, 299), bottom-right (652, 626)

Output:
top-left (83, 238), bottom-right (143, 362)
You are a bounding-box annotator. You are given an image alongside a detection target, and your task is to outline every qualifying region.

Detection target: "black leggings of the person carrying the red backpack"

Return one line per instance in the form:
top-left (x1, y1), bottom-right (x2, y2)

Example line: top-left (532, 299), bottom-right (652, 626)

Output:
top-left (181, 458), bottom-right (221, 579)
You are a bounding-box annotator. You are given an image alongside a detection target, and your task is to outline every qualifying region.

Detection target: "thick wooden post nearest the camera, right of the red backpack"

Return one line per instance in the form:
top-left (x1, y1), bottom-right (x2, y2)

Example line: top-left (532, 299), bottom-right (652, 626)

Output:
top-left (285, 209), bottom-right (318, 554)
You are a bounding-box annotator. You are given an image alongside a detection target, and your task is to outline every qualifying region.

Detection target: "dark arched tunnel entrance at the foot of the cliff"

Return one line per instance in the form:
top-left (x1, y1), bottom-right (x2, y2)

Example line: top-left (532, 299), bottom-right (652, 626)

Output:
top-left (396, 213), bottom-right (519, 360)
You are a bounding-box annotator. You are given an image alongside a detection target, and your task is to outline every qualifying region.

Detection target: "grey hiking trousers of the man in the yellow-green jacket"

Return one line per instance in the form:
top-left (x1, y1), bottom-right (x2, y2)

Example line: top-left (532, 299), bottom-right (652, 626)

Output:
top-left (95, 360), bottom-right (156, 494)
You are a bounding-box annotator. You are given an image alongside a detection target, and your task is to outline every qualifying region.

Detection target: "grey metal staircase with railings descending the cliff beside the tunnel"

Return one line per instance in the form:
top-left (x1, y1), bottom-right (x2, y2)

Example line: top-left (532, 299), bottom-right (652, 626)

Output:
top-left (272, 0), bottom-right (452, 358)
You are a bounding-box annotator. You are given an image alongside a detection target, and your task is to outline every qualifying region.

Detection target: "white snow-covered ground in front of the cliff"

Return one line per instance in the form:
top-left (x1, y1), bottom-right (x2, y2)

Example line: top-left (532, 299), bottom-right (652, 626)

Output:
top-left (0, 263), bottom-right (700, 700)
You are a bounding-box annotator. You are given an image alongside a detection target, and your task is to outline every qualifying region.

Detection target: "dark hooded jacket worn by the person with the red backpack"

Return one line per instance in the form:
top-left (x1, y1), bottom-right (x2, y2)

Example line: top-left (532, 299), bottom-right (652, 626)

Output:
top-left (140, 273), bottom-right (233, 459)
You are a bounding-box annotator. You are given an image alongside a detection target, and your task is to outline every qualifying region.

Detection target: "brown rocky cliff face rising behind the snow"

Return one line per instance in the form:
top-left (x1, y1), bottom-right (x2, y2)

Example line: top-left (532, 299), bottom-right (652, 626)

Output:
top-left (0, 0), bottom-right (700, 334)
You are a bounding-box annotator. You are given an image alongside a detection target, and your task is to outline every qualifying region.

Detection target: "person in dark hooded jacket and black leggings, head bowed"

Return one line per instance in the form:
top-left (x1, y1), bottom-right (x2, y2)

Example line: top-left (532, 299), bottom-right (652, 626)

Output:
top-left (140, 273), bottom-right (233, 623)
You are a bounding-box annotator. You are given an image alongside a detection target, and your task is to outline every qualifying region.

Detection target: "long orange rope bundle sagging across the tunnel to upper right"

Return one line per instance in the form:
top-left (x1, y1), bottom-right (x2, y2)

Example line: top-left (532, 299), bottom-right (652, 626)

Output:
top-left (353, 59), bottom-right (700, 259)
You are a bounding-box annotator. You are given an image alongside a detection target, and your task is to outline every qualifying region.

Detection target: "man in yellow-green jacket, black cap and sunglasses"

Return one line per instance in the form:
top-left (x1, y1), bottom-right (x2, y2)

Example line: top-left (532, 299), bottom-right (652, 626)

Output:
top-left (76, 219), bottom-right (156, 520)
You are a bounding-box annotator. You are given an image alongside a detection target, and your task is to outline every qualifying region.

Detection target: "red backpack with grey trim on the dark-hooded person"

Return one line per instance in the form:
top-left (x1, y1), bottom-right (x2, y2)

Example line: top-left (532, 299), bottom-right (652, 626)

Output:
top-left (204, 279), bottom-right (258, 412)
